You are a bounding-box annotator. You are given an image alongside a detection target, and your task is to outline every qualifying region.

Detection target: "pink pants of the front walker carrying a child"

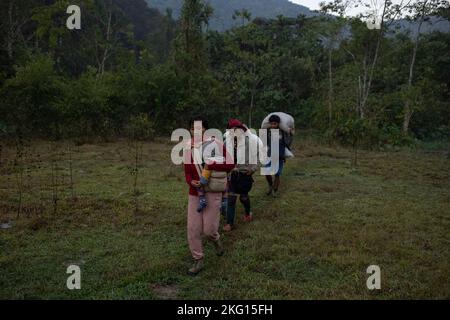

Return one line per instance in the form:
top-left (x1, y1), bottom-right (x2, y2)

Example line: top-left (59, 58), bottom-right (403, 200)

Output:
top-left (187, 192), bottom-right (222, 260)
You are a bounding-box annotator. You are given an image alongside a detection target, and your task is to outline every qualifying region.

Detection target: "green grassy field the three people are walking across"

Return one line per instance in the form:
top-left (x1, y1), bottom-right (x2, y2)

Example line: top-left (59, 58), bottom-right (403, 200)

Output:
top-left (0, 138), bottom-right (450, 299)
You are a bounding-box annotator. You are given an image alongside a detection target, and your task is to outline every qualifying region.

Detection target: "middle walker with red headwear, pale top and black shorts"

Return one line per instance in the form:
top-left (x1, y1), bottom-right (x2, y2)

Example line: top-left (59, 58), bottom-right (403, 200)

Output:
top-left (223, 119), bottom-right (265, 232)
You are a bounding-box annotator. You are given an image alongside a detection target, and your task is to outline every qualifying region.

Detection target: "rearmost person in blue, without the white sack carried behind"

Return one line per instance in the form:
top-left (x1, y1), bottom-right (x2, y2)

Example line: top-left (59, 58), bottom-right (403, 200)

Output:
top-left (265, 115), bottom-right (287, 197)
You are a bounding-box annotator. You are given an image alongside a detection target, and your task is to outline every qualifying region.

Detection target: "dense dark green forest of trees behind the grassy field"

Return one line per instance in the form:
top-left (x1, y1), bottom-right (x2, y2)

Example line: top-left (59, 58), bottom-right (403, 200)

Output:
top-left (0, 0), bottom-right (450, 148)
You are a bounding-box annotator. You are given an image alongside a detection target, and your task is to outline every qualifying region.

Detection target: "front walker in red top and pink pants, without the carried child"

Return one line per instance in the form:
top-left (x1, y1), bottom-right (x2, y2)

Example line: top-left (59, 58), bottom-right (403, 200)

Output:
top-left (184, 117), bottom-right (234, 275)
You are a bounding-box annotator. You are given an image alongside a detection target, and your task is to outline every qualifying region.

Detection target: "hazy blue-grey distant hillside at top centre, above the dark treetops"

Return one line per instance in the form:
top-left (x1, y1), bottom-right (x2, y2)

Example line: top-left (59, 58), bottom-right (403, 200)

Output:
top-left (146, 0), bottom-right (316, 31)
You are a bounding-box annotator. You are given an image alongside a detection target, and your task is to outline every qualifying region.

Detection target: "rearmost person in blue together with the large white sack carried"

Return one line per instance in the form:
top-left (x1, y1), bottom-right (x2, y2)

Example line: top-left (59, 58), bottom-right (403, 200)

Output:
top-left (261, 112), bottom-right (295, 197)
